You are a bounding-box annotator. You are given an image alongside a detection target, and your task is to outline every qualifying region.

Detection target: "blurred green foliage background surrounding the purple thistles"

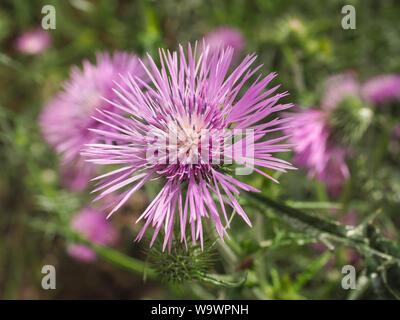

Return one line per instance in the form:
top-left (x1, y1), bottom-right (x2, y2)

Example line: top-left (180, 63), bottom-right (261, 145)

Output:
top-left (0, 0), bottom-right (400, 299)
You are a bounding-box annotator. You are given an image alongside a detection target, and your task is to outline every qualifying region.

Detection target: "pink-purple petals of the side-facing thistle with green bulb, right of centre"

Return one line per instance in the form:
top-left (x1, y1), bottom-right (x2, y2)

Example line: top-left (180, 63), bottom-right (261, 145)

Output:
top-left (286, 73), bottom-right (360, 197)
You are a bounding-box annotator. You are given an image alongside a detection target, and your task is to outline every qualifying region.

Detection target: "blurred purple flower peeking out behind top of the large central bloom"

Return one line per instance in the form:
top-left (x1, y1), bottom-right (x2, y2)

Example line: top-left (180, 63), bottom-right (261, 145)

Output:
top-left (204, 27), bottom-right (244, 57)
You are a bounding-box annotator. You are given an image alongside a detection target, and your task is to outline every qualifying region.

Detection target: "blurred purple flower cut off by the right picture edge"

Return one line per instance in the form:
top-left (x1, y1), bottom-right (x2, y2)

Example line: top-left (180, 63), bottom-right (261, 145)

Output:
top-left (362, 74), bottom-right (400, 104)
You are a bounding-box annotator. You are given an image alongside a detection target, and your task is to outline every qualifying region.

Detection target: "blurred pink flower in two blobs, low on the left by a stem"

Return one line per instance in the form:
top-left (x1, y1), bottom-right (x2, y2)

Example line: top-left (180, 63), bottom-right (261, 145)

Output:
top-left (68, 208), bottom-right (118, 262)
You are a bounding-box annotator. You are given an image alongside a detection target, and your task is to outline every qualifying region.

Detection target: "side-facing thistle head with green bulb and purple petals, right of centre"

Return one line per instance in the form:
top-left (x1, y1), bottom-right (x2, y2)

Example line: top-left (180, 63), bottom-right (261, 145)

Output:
top-left (286, 73), bottom-right (364, 197)
